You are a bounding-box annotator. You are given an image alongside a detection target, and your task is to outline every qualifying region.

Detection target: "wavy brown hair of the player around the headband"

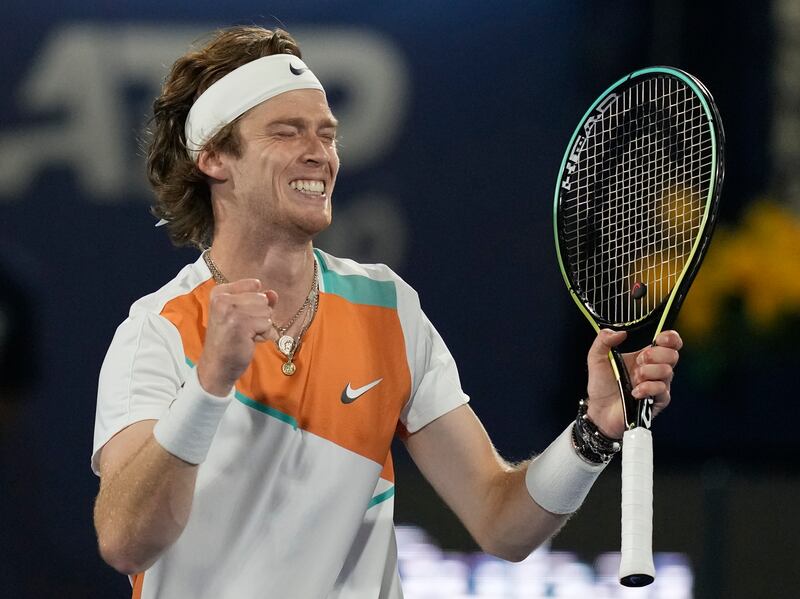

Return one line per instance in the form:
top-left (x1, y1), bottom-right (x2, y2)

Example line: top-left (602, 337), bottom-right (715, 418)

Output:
top-left (147, 26), bottom-right (302, 248)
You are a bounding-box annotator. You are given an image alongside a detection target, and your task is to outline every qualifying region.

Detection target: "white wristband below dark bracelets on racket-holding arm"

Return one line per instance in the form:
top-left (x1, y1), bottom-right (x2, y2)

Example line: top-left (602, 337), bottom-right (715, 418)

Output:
top-left (525, 424), bottom-right (606, 514)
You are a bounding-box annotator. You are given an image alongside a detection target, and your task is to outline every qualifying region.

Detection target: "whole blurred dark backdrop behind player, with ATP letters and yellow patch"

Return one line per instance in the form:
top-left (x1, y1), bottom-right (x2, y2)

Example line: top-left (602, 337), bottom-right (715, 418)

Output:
top-left (0, 0), bottom-right (800, 599)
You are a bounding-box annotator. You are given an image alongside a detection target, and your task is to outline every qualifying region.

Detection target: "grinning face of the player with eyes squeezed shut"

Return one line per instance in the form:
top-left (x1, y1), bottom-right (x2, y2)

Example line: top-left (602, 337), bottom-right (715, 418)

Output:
top-left (219, 89), bottom-right (339, 237)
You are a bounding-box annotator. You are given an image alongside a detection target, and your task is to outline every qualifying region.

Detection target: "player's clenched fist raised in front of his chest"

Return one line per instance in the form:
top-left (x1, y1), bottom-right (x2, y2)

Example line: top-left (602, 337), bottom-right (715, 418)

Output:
top-left (197, 279), bottom-right (278, 397)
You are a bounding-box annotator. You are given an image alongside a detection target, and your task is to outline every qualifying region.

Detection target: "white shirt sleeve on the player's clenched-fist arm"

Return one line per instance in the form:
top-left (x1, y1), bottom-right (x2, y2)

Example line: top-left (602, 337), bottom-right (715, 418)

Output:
top-left (91, 313), bottom-right (188, 474)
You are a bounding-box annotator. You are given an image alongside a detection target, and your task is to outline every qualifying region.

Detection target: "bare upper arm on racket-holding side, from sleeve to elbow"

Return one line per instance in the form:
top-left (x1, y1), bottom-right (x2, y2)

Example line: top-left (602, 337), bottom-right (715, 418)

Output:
top-left (405, 405), bottom-right (513, 543)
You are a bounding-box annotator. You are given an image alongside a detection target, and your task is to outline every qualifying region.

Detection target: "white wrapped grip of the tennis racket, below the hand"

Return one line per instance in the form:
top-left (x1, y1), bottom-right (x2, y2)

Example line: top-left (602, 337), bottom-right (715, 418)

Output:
top-left (619, 427), bottom-right (656, 587)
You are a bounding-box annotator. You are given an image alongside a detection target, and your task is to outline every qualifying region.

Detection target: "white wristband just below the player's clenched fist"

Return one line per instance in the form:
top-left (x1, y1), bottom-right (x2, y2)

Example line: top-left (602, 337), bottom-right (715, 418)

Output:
top-left (153, 368), bottom-right (233, 464)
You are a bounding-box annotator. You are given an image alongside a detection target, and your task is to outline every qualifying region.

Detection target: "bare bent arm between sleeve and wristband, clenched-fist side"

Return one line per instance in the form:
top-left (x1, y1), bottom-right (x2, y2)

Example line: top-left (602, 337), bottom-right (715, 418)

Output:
top-left (94, 435), bottom-right (197, 574)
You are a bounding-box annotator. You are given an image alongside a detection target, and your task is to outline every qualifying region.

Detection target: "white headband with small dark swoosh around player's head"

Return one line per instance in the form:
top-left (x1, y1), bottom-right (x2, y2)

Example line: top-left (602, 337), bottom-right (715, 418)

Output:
top-left (185, 54), bottom-right (325, 161)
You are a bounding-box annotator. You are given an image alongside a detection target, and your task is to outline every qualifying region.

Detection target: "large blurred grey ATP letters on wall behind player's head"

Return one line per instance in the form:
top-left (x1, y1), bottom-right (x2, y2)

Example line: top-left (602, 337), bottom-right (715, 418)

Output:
top-left (0, 22), bottom-right (410, 204)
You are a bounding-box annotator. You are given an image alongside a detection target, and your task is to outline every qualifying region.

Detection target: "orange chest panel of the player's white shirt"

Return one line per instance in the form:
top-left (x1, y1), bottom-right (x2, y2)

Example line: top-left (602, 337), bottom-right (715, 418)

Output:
top-left (161, 280), bottom-right (411, 480)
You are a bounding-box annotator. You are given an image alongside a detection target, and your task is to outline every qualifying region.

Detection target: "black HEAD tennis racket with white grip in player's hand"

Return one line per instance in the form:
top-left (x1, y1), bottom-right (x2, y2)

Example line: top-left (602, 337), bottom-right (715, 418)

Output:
top-left (553, 67), bottom-right (724, 587)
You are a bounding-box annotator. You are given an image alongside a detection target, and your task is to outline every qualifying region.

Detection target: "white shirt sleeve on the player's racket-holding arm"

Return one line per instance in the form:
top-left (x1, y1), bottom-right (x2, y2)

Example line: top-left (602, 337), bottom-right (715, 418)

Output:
top-left (398, 285), bottom-right (469, 433)
